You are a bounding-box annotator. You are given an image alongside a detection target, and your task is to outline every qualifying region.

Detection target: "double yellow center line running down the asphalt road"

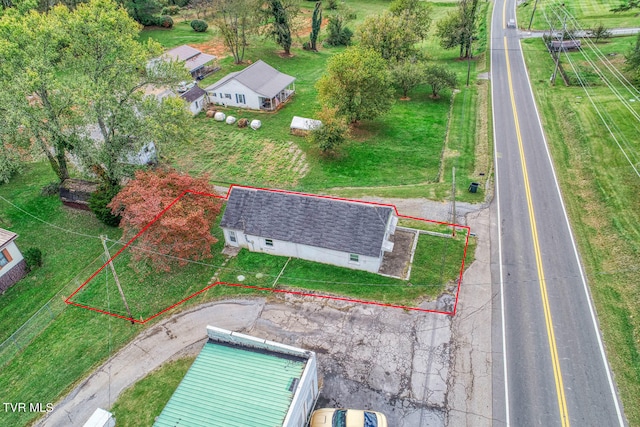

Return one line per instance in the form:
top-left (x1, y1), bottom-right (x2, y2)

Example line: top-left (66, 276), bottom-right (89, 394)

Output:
top-left (504, 37), bottom-right (569, 427)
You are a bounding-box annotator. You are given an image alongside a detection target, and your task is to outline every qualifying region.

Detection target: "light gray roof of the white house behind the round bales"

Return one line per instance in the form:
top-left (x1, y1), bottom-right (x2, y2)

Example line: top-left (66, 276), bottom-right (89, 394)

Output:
top-left (207, 59), bottom-right (296, 98)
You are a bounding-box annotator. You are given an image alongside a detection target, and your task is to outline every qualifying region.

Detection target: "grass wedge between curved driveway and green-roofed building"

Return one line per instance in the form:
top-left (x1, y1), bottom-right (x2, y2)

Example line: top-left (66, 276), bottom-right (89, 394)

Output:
top-left (111, 357), bottom-right (195, 427)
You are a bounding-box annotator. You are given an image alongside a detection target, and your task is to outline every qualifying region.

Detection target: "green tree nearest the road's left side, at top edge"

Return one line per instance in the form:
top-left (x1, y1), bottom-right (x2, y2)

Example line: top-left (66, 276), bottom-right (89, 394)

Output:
top-left (436, 0), bottom-right (478, 58)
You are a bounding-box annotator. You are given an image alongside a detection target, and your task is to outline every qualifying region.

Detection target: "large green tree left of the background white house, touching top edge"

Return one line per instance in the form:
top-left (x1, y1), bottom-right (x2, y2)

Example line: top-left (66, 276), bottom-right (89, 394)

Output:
top-left (67, 0), bottom-right (188, 186)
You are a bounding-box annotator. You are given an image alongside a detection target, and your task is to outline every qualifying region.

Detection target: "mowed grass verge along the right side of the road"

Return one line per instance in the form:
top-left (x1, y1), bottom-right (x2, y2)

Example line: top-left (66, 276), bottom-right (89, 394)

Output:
top-left (523, 40), bottom-right (640, 425)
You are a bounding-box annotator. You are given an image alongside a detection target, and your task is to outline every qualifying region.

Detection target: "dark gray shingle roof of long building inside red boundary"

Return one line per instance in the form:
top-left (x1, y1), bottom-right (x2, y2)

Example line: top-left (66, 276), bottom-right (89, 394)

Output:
top-left (220, 187), bottom-right (393, 257)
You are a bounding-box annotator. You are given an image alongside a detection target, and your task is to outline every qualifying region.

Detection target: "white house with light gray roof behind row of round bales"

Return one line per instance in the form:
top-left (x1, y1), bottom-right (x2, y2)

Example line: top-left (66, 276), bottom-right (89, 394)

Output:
top-left (205, 60), bottom-right (296, 111)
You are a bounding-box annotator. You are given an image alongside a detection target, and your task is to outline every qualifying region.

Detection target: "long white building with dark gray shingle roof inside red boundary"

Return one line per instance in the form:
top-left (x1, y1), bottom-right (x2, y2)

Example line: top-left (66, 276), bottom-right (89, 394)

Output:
top-left (220, 187), bottom-right (398, 273)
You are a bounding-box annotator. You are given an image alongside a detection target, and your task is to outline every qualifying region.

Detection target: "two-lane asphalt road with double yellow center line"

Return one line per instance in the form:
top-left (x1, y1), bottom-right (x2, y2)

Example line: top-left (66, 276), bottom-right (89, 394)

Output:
top-left (491, 0), bottom-right (626, 426)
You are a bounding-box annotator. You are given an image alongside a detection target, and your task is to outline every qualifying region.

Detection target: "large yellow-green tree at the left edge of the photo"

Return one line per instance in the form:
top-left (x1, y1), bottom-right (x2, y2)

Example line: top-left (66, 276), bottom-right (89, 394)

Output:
top-left (0, 6), bottom-right (81, 182)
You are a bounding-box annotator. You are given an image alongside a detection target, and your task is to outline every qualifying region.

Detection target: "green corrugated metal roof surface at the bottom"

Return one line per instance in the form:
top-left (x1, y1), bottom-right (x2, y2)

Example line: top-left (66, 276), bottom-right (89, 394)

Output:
top-left (154, 341), bottom-right (306, 427)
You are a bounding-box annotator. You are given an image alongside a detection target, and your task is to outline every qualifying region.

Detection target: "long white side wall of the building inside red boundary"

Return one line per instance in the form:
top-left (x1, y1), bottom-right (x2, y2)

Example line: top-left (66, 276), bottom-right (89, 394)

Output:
top-left (223, 228), bottom-right (382, 273)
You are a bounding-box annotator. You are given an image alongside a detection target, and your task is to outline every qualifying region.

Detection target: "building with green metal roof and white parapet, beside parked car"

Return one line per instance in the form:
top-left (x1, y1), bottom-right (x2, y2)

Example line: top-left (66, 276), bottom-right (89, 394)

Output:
top-left (154, 326), bottom-right (318, 427)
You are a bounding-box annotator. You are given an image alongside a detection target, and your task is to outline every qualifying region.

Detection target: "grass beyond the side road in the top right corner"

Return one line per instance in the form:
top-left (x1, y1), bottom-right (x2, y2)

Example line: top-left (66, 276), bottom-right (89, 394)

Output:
top-left (516, 0), bottom-right (638, 31)
